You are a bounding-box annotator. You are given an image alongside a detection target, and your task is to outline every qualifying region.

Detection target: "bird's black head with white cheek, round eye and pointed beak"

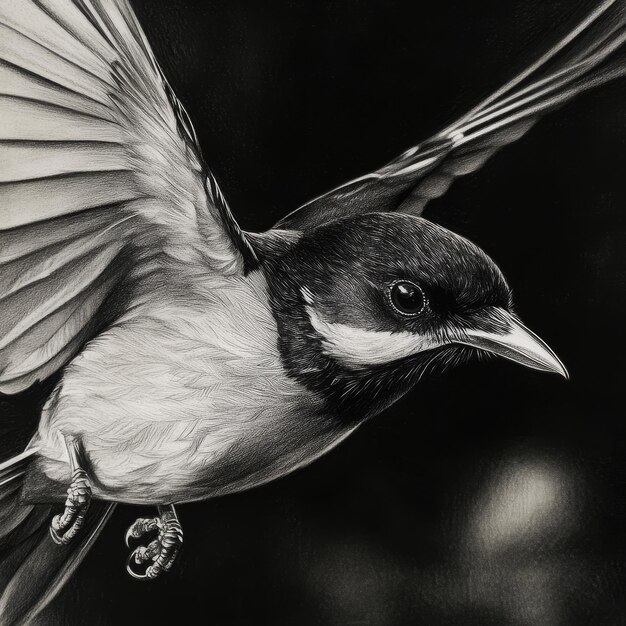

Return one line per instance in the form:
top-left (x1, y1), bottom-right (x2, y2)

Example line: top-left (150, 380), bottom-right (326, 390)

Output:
top-left (267, 213), bottom-right (567, 418)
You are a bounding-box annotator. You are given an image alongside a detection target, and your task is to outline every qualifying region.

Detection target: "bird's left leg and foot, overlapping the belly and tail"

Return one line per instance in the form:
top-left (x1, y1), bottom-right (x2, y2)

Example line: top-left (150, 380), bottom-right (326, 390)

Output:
top-left (50, 436), bottom-right (91, 544)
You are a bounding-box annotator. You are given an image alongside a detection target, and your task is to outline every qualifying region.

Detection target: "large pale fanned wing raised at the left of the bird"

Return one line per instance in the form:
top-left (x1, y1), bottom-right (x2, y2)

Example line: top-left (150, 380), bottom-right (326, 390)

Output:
top-left (0, 0), bottom-right (255, 393)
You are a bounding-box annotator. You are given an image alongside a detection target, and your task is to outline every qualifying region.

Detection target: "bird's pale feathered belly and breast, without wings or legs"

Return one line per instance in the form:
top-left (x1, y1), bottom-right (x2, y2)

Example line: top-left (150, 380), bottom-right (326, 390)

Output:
top-left (30, 280), bottom-right (342, 503)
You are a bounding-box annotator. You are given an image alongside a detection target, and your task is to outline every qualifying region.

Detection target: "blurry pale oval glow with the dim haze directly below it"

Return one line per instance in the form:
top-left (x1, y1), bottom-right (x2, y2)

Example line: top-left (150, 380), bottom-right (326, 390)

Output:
top-left (460, 455), bottom-right (584, 625)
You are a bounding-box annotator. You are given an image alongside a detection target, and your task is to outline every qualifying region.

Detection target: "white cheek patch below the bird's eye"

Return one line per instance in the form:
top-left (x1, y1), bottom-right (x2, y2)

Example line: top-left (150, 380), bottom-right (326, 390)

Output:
top-left (307, 306), bottom-right (446, 368)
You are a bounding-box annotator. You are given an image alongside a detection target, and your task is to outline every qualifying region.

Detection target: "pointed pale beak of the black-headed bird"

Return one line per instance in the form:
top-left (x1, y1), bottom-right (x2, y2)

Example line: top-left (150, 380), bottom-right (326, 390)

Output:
top-left (456, 308), bottom-right (569, 379)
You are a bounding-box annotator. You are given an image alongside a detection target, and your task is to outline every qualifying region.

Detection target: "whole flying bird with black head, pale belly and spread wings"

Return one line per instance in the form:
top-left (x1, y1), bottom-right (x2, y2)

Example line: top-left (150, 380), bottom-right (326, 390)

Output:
top-left (0, 0), bottom-right (626, 625)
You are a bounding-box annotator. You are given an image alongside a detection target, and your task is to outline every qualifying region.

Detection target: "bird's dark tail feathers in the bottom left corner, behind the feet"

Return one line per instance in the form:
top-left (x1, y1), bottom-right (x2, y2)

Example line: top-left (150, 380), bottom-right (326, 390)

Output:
top-left (0, 449), bottom-right (115, 626)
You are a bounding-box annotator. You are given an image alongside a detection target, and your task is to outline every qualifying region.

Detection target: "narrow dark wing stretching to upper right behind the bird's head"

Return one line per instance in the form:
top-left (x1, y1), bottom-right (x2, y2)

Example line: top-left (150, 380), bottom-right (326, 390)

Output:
top-left (275, 0), bottom-right (626, 231)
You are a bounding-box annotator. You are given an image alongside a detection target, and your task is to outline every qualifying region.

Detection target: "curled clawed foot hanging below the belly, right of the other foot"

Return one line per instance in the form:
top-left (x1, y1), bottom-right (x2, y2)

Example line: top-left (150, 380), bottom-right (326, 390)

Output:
top-left (126, 504), bottom-right (183, 580)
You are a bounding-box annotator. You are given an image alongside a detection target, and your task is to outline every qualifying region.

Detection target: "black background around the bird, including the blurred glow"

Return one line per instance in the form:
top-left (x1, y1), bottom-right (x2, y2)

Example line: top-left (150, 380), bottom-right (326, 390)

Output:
top-left (18, 0), bottom-right (626, 626)
